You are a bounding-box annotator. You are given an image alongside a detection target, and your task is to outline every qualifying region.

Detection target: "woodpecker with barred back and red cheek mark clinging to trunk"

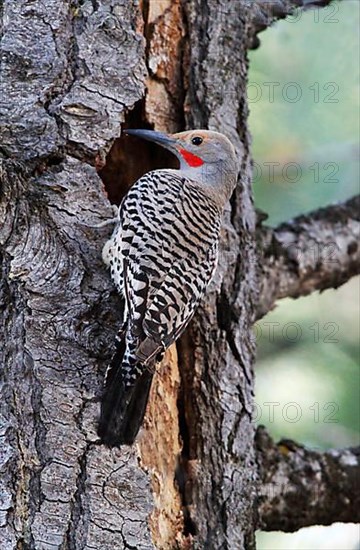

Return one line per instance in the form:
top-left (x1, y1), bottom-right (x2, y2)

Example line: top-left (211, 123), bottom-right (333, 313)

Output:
top-left (98, 130), bottom-right (237, 445)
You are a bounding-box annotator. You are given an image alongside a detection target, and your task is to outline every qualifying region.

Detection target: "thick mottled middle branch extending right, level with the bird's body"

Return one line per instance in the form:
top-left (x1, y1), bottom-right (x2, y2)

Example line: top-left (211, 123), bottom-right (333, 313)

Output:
top-left (258, 196), bottom-right (360, 317)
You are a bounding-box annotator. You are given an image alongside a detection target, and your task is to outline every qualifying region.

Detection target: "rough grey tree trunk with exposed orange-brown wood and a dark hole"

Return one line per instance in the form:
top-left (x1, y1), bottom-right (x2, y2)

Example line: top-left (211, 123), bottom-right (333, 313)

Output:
top-left (0, 0), bottom-right (358, 550)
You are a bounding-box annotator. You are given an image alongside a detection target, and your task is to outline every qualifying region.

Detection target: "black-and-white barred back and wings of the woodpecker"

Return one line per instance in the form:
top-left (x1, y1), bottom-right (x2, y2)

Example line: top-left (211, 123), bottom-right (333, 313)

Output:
top-left (119, 171), bottom-right (221, 354)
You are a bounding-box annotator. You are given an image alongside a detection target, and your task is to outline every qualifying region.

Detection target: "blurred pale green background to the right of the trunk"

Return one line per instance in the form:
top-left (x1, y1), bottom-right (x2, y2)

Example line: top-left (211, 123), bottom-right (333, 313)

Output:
top-left (248, 0), bottom-right (360, 550)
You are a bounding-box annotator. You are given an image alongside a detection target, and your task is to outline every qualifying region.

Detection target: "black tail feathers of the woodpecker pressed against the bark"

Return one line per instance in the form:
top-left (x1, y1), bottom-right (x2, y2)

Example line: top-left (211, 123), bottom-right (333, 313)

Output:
top-left (98, 344), bottom-right (153, 446)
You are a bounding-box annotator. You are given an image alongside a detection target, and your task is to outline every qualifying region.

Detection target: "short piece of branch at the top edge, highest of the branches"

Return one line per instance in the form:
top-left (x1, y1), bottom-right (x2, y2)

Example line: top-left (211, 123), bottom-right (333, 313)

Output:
top-left (249, 0), bottom-right (332, 49)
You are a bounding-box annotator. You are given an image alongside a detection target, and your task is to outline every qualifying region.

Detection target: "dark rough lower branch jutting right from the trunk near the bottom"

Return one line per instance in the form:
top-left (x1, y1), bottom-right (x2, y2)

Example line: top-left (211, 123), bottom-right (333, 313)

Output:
top-left (256, 426), bottom-right (360, 532)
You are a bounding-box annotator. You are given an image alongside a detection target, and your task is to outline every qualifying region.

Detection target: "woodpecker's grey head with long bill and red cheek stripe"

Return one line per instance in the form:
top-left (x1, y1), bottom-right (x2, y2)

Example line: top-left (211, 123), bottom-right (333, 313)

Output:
top-left (125, 130), bottom-right (237, 203)
